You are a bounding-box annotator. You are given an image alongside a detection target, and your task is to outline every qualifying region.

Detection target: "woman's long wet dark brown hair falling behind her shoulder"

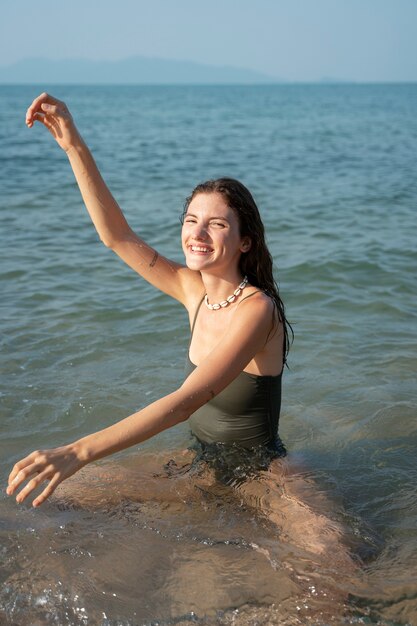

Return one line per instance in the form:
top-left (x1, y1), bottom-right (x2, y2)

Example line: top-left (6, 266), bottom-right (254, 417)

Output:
top-left (183, 178), bottom-right (294, 363)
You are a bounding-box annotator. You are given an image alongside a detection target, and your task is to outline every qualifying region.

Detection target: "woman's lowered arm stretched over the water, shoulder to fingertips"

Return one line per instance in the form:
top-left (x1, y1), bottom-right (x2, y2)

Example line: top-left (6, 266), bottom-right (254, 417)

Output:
top-left (7, 295), bottom-right (273, 506)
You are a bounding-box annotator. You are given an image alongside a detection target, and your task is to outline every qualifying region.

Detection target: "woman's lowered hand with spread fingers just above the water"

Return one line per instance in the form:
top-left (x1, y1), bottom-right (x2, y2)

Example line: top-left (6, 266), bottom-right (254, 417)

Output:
top-left (6, 444), bottom-right (85, 507)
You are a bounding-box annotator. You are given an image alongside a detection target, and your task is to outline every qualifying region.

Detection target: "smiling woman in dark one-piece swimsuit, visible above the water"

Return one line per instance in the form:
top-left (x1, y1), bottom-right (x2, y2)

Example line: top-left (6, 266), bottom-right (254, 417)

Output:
top-left (7, 93), bottom-right (291, 506)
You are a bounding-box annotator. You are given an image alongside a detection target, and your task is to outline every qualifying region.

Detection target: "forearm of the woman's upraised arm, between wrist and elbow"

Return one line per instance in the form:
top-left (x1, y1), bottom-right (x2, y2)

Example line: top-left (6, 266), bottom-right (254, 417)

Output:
top-left (66, 135), bottom-right (130, 247)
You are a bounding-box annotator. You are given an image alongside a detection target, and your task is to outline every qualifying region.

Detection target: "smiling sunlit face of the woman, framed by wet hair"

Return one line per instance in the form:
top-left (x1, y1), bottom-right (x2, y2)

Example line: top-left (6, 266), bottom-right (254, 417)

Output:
top-left (182, 192), bottom-right (250, 276)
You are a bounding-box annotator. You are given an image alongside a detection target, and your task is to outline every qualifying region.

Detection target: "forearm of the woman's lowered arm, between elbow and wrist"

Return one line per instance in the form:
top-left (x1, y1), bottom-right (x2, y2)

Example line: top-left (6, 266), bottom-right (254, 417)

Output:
top-left (74, 391), bottom-right (193, 463)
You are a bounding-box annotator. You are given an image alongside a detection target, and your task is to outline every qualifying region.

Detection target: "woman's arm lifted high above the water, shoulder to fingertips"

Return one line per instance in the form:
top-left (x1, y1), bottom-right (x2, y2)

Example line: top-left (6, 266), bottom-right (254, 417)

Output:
top-left (26, 93), bottom-right (203, 305)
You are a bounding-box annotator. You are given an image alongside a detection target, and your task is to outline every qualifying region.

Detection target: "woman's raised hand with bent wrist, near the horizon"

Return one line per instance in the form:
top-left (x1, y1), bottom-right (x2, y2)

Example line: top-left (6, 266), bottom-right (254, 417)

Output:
top-left (26, 93), bottom-right (81, 152)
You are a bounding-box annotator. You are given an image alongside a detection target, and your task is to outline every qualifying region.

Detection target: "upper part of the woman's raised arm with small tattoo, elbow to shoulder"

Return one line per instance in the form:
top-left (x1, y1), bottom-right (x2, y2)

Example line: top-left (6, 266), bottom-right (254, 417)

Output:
top-left (111, 228), bottom-right (204, 306)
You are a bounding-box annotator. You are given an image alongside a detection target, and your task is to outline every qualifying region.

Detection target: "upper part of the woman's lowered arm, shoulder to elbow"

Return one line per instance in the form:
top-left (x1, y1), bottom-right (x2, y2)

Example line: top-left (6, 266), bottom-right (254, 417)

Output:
top-left (179, 297), bottom-right (274, 417)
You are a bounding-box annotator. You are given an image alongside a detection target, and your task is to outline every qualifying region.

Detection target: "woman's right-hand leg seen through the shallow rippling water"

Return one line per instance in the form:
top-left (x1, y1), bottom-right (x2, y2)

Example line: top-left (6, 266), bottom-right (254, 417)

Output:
top-left (231, 459), bottom-right (362, 624)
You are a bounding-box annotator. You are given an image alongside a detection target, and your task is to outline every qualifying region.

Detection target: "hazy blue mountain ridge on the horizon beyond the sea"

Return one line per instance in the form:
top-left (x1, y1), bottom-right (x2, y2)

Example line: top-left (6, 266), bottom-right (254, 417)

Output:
top-left (0, 57), bottom-right (283, 85)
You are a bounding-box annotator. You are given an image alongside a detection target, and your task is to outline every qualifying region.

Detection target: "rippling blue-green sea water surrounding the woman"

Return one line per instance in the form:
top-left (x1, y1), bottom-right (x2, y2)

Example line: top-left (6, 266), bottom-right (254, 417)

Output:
top-left (0, 85), bottom-right (417, 626)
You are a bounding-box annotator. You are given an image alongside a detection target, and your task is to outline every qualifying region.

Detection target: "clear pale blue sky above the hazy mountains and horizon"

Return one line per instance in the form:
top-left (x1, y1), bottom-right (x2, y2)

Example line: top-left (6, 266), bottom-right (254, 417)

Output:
top-left (0, 0), bottom-right (417, 81)
